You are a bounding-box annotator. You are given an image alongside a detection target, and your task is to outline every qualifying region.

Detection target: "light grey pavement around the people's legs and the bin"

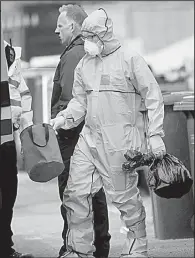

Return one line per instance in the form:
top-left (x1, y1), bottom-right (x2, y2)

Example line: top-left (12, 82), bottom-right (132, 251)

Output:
top-left (12, 172), bottom-right (194, 258)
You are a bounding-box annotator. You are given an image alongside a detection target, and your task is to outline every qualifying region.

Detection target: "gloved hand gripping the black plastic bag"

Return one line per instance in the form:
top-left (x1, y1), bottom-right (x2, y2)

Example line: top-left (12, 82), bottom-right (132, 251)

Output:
top-left (149, 135), bottom-right (166, 159)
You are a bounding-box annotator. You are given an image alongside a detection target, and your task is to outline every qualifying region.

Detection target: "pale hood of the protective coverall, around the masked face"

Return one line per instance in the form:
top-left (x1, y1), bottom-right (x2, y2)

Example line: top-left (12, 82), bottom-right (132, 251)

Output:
top-left (81, 10), bottom-right (120, 56)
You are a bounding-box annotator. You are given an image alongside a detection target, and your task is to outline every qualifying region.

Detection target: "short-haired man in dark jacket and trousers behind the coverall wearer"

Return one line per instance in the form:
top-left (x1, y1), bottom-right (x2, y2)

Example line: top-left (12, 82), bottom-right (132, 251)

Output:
top-left (51, 4), bottom-right (110, 258)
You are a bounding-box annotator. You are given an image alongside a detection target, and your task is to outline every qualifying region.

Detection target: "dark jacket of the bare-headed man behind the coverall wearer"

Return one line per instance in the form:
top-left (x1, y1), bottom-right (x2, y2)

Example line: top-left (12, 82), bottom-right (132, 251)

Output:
top-left (51, 36), bottom-right (85, 138)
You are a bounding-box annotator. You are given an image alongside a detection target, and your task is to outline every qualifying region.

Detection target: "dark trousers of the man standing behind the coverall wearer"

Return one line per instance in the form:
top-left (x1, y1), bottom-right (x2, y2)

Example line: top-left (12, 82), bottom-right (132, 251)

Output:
top-left (58, 136), bottom-right (111, 258)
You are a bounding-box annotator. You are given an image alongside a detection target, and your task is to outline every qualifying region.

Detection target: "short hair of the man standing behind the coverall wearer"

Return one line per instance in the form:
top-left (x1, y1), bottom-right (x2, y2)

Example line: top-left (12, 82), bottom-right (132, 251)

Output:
top-left (59, 4), bottom-right (88, 26)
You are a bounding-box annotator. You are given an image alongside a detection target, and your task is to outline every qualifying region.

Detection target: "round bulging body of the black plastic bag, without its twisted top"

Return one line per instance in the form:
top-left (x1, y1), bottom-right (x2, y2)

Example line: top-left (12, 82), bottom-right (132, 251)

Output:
top-left (147, 154), bottom-right (193, 199)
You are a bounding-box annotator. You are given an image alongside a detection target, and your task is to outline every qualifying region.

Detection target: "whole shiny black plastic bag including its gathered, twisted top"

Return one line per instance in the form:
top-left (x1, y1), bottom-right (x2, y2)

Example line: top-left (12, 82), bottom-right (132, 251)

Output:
top-left (122, 151), bottom-right (193, 199)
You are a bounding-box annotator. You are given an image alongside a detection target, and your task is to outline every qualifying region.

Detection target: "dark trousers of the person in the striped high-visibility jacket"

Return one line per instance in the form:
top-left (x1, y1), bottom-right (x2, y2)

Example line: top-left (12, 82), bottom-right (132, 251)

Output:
top-left (0, 141), bottom-right (18, 257)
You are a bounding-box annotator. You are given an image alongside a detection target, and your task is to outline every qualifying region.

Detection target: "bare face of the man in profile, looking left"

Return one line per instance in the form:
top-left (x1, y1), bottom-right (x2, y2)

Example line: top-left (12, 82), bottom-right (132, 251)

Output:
top-left (55, 12), bottom-right (73, 46)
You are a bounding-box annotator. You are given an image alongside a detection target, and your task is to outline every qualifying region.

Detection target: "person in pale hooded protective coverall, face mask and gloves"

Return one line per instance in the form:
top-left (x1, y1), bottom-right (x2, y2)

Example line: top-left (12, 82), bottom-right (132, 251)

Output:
top-left (51, 8), bottom-right (166, 257)
